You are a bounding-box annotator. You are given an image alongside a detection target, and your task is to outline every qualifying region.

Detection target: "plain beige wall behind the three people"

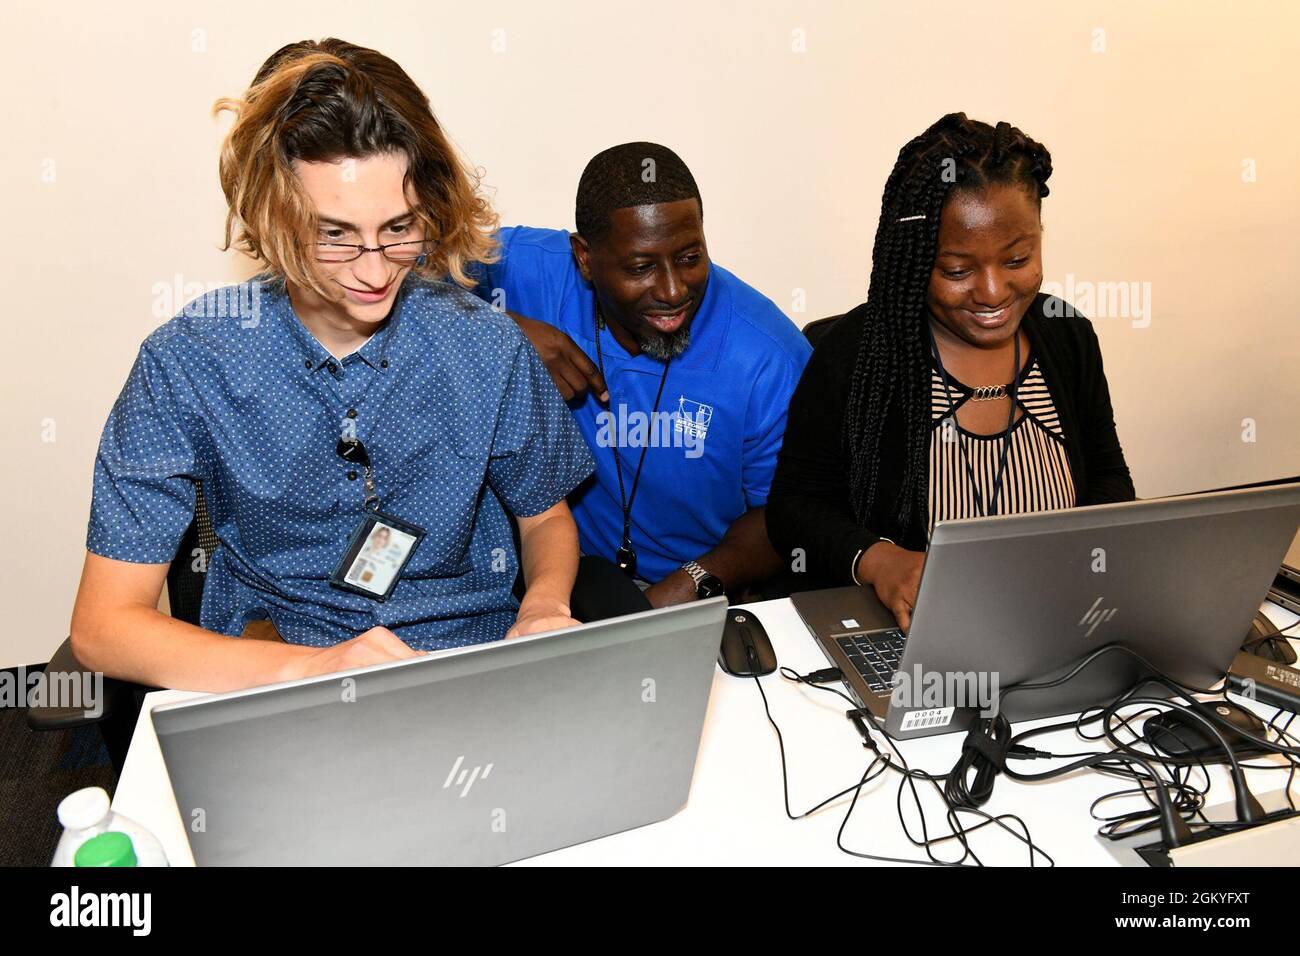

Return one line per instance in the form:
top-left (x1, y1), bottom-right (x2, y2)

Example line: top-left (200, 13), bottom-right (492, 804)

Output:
top-left (0, 0), bottom-right (1300, 666)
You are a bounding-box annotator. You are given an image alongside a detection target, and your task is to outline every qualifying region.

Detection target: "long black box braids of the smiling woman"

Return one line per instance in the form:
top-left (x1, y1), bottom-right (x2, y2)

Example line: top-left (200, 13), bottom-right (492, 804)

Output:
top-left (844, 113), bottom-right (1052, 532)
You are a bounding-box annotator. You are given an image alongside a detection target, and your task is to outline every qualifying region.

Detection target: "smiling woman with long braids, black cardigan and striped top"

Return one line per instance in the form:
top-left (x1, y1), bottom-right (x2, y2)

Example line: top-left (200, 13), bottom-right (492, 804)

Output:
top-left (767, 113), bottom-right (1134, 630)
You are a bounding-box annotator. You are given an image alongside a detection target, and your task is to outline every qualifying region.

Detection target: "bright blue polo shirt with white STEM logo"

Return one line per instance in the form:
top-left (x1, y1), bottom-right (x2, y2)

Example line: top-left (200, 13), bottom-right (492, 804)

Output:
top-left (477, 226), bottom-right (813, 581)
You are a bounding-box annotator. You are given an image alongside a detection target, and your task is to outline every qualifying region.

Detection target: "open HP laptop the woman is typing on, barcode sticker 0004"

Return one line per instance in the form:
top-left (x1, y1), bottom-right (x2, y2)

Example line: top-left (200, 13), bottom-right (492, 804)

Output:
top-left (793, 484), bottom-right (1300, 737)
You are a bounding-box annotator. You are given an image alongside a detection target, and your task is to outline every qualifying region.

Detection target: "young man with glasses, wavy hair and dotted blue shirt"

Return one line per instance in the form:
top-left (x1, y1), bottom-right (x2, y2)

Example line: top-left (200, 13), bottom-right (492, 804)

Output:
top-left (72, 39), bottom-right (593, 691)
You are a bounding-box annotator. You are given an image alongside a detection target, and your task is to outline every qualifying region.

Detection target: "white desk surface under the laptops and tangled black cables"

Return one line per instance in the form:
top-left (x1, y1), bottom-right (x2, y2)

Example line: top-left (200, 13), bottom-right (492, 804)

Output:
top-left (113, 601), bottom-right (1297, 866)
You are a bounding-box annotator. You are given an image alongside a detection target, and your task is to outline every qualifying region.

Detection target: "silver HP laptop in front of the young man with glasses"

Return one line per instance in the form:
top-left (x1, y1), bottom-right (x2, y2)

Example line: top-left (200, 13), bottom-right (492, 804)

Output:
top-left (153, 597), bottom-right (727, 866)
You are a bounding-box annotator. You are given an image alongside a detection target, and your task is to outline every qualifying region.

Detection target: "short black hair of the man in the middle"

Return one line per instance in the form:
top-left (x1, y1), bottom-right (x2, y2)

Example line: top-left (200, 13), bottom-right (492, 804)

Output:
top-left (573, 143), bottom-right (705, 242)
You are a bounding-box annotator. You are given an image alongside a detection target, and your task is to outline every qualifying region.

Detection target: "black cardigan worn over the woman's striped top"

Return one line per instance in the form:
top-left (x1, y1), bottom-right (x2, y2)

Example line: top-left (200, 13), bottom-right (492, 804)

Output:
top-left (767, 293), bottom-right (1134, 588)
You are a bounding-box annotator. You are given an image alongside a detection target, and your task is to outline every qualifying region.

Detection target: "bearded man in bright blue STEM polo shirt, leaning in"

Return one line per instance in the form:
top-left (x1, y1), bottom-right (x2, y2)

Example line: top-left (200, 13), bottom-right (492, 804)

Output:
top-left (477, 143), bottom-right (811, 606)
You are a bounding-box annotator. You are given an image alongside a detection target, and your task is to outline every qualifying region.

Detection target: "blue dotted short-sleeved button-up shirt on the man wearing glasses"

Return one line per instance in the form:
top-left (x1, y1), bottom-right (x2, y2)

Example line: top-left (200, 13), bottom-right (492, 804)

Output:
top-left (86, 273), bottom-right (592, 650)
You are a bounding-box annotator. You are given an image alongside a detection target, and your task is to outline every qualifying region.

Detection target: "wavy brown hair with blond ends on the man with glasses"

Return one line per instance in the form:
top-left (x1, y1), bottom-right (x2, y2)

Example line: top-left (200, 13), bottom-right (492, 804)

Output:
top-left (213, 38), bottom-right (498, 298)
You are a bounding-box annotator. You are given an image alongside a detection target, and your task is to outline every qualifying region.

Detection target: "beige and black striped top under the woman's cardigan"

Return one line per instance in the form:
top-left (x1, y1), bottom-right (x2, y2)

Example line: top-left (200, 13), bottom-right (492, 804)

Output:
top-left (930, 355), bottom-right (1075, 533)
